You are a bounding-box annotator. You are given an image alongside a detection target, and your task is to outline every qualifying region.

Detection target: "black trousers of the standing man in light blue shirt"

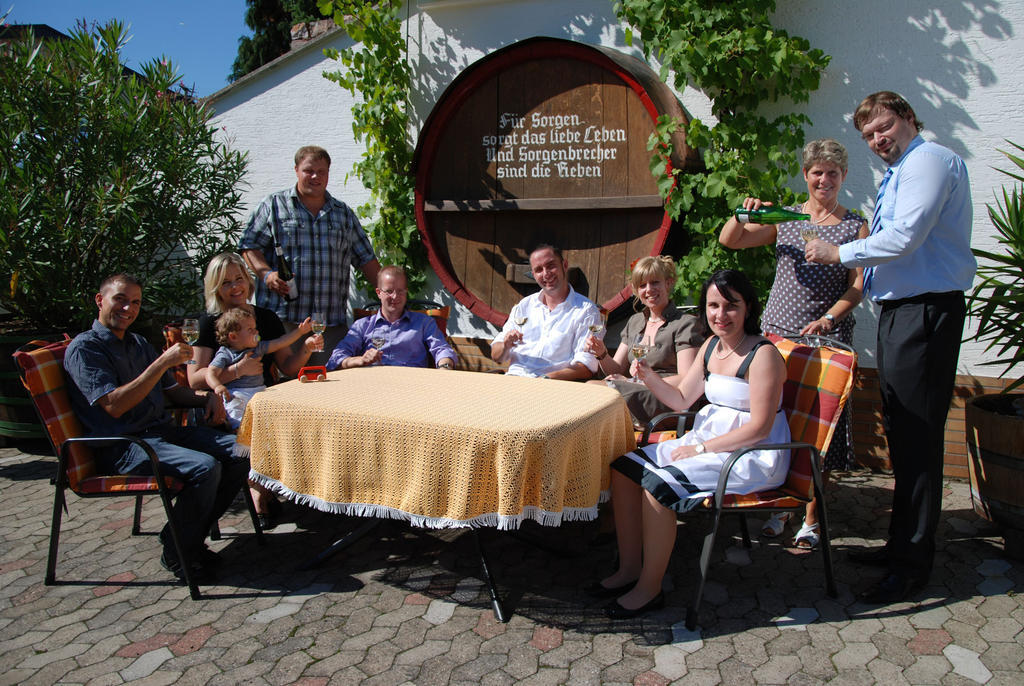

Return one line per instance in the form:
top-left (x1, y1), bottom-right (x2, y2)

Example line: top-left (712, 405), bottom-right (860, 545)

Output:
top-left (878, 291), bottom-right (967, 580)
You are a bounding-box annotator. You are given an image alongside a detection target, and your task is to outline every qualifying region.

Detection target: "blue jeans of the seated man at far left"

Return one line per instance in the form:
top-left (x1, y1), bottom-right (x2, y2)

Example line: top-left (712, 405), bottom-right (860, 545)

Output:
top-left (115, 425), bottom-right (249, 560)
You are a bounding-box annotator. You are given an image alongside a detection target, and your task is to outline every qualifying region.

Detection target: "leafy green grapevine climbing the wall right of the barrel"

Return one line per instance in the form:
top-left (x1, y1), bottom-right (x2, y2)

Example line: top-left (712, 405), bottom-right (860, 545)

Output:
top-left (615, 0), bottom-right (829, 299)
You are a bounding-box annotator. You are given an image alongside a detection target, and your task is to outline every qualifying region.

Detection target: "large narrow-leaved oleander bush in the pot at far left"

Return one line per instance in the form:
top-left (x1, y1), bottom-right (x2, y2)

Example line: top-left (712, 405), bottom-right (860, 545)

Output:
top-left (0, 22), bottom-right (246, 329)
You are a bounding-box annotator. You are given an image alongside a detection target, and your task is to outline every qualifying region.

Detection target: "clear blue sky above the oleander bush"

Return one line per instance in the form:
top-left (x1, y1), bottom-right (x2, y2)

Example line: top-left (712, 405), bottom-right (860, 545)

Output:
top-left (0, 0), bottom-right (252, 96)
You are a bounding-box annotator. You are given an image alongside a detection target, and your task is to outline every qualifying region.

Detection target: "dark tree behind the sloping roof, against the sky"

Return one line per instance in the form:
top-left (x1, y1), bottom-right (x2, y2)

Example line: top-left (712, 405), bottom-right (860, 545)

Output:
top-left (228, 0), bottom-right (321, 81)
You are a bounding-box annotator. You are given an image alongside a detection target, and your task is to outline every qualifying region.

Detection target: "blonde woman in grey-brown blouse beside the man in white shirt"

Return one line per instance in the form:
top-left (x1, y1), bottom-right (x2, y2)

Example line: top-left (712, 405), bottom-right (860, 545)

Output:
top-left (587, 255), bottom-right (706, 424)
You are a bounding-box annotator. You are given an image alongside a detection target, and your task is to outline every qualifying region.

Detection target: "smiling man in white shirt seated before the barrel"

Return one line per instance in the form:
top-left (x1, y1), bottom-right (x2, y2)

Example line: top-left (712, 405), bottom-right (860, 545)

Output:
top-left (490, 245), bottom-right (601, 381)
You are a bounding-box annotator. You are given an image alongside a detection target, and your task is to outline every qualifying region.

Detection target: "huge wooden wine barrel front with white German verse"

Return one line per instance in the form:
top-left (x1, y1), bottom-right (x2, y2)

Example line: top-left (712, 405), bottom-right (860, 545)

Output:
top-left (416, 38), bottom-right (700, 326)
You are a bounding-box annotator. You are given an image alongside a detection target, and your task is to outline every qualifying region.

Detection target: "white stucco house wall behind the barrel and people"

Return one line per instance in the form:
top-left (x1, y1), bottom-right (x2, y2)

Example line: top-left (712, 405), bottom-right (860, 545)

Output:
top-left (210, 0), bottom-right (1024, 376)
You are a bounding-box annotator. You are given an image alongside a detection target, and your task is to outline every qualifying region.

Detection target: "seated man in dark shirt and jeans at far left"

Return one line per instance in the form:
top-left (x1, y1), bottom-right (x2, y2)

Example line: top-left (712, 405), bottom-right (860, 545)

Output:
top-left (63, 273), bottom-right (249, 582)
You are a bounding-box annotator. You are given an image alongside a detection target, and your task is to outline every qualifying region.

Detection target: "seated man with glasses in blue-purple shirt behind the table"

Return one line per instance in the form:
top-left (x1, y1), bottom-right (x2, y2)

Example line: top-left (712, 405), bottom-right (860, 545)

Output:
top-left (327, 266), bottom-right (456, 370)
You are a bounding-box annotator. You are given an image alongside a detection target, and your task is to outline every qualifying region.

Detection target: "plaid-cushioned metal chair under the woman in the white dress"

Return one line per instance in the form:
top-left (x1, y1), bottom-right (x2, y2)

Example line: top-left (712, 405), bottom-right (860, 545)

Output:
top-left (638, 336), bottom-right (857, 631)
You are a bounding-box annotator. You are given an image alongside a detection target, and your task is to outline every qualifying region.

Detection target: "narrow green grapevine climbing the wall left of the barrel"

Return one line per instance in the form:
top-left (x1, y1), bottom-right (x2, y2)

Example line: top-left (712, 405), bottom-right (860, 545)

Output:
top-left (319, 0), bottom-right (419, 293)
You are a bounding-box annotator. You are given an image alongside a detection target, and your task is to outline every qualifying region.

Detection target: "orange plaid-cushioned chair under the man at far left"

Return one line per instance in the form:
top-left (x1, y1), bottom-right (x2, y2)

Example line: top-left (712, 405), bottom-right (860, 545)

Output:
top-left (14, 335), bottom-right (262, 600)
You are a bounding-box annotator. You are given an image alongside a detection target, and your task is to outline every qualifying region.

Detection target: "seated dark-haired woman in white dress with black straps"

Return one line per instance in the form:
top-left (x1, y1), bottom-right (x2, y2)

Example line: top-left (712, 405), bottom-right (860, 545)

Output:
top-left (585, 269), bottom-right (790, 618)
